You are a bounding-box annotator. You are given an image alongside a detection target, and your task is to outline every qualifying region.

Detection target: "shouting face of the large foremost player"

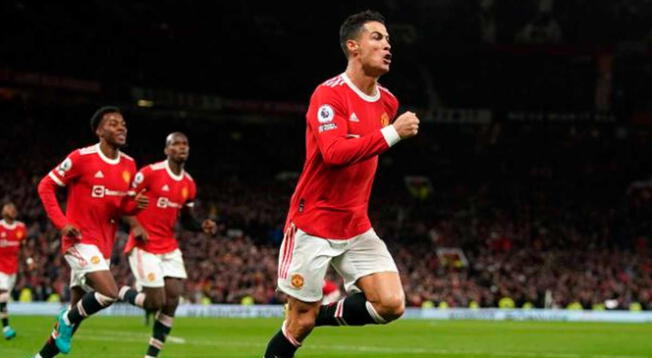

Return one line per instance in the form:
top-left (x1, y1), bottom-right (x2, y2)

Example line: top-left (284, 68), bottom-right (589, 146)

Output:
top-left (357, 21), bottom-right (392, 76)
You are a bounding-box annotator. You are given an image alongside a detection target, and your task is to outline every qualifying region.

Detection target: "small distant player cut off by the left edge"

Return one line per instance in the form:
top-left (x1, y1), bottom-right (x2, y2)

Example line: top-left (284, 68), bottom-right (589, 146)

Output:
top-left (0, 203), bottom-right (27, 340)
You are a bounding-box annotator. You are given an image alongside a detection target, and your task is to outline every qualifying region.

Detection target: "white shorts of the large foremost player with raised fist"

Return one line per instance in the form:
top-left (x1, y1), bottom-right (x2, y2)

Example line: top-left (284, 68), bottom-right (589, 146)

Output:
top-left (277, 225), bottom-right (398, 302)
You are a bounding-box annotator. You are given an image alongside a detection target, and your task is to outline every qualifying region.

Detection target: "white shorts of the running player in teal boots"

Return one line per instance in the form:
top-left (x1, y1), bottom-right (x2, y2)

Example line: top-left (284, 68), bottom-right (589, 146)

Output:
top-left (63, 244), bottom-right (111, 291)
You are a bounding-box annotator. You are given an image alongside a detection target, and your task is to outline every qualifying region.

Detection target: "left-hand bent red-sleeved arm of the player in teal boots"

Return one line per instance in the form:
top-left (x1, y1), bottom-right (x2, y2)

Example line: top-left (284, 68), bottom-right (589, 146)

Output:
top-left (38, 151), bottom-right (81, 237)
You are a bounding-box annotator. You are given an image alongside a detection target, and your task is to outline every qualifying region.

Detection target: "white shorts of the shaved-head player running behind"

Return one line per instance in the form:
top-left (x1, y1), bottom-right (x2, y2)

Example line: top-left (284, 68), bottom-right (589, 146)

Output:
top-left (129, 247), bottom-right (188, 290)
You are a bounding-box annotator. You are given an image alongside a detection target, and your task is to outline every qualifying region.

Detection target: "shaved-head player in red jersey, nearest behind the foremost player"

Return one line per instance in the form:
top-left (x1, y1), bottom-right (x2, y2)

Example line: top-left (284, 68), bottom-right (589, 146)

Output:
top-left (119, 132), bottom-right (217, 358)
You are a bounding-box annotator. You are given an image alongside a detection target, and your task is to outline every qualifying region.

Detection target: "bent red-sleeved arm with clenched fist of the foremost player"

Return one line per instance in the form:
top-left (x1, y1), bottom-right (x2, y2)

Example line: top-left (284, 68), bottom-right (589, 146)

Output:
top-left (307, 87), bottom-right (418, 165)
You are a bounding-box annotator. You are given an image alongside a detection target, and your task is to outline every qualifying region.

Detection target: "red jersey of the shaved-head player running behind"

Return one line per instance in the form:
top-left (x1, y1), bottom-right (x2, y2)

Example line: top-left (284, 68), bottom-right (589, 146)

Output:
top-left (125, 160), bottom-right (197, 254)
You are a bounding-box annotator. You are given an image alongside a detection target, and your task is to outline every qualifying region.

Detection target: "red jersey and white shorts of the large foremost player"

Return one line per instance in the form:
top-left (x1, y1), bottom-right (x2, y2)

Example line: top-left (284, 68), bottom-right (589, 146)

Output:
top-left (278, 73), bottom-right (400, 302)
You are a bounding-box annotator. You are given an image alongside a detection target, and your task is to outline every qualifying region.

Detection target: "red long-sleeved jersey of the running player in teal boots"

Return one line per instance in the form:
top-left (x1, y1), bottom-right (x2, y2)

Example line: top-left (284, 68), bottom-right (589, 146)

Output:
top-left (39, 143), bottom-right (136, 259)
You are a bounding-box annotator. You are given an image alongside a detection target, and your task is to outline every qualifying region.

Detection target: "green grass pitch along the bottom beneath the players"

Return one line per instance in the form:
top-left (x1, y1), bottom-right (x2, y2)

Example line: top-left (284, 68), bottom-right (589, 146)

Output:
top-left (0, 316), bottom-right (652, 358)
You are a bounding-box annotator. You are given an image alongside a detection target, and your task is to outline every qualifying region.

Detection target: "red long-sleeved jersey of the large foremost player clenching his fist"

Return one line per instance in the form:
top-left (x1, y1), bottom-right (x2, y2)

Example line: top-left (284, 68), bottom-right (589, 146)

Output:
top-left (286, 73), bottom-right (400, 239)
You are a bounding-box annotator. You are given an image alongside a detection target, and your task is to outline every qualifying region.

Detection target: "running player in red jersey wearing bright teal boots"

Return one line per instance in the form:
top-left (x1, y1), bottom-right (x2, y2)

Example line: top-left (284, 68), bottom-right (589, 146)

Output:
top-left (35, 107), bottom-right (149, 358)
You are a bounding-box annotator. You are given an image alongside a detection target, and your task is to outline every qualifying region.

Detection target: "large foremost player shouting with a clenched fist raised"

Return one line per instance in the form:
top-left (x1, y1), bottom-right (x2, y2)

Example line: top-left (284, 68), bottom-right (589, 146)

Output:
top-left (265, 10), bottom-right (419, 358)
